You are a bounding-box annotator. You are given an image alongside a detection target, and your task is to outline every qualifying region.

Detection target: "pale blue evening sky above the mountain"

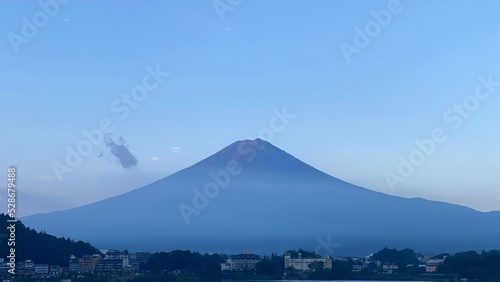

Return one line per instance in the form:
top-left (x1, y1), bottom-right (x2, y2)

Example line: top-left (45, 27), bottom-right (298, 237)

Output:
top-left (0, 0), bottom-right (500, 215)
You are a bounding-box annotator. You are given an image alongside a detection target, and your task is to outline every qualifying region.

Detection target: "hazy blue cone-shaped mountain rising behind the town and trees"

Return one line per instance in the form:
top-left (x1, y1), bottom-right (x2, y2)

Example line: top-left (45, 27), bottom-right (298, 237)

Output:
top-left (23, 139), bottom-right (500, 255)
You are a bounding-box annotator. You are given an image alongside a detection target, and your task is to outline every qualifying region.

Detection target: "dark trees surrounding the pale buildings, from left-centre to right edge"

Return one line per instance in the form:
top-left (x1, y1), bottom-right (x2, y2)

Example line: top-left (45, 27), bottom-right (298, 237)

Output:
top-left (136, 248), bottom-right (500, 281)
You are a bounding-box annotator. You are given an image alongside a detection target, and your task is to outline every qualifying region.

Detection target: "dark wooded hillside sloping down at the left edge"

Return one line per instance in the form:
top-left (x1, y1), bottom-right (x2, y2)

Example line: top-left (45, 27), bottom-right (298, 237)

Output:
top-left (0, 213), bottom-right (101, 266)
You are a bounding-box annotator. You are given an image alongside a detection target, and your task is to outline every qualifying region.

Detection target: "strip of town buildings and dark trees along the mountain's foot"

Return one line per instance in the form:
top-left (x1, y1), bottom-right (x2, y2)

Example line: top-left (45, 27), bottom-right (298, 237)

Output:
top-left (0, 248), bottom-right (500, 282)
